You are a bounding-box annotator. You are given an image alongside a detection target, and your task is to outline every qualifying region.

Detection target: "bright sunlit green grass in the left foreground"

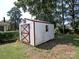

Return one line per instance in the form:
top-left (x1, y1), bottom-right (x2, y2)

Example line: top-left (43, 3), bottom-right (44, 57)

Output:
top-left (0, 43), bottom-right (25, 59)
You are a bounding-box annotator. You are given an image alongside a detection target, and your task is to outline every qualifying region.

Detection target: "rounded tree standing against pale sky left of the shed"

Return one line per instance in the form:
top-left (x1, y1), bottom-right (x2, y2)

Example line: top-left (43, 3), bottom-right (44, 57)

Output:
top-left (7, 7), bottom-right (22, 29)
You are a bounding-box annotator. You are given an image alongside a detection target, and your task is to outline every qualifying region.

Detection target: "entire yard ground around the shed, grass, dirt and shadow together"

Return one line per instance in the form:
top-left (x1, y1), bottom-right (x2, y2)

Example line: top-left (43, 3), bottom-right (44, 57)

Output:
top-left (0, 34), bottom-right (79, 59)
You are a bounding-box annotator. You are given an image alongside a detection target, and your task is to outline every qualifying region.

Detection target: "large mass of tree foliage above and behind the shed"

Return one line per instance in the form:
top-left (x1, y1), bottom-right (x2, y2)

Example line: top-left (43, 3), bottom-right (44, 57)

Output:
top-left (14, 0), bottom-right (79, 32)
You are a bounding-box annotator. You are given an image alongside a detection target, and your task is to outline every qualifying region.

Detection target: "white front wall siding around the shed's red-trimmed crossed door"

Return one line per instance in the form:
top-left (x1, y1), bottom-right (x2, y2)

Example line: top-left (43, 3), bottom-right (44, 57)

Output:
top-left (19, 21), bottom-right (34, 46)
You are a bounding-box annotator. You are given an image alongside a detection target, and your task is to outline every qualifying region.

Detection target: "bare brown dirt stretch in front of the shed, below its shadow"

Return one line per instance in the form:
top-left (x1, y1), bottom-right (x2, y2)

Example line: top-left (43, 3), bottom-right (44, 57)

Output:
top-left (26, 44), bottom-right (75, 59)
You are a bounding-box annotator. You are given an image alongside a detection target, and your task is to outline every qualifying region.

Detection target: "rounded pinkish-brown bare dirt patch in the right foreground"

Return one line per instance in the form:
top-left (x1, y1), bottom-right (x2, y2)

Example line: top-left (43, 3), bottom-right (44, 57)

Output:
top-left (49, 44), bottom-right (75, 59)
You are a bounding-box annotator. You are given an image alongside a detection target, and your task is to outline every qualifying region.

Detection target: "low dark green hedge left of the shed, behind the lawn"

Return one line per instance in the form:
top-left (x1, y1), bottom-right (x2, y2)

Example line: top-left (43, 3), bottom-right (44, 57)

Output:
top-left (0, 32), bottom-right (19, 43)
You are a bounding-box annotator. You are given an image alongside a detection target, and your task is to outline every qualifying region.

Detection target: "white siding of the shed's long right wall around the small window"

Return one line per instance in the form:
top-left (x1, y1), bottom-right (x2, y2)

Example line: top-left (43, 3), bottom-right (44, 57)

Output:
top-left (35, 22), bottom-right (54, 45)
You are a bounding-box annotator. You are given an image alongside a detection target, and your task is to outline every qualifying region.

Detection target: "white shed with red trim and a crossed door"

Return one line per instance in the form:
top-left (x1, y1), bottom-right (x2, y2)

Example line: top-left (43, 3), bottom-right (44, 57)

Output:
top-left (19, 19), bottom-right (54, 46)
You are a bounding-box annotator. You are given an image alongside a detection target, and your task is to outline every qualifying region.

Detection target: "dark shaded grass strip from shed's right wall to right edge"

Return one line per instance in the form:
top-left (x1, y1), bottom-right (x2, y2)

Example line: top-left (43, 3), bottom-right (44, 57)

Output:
top-left (36, 35), bottom-right (79, 50)
